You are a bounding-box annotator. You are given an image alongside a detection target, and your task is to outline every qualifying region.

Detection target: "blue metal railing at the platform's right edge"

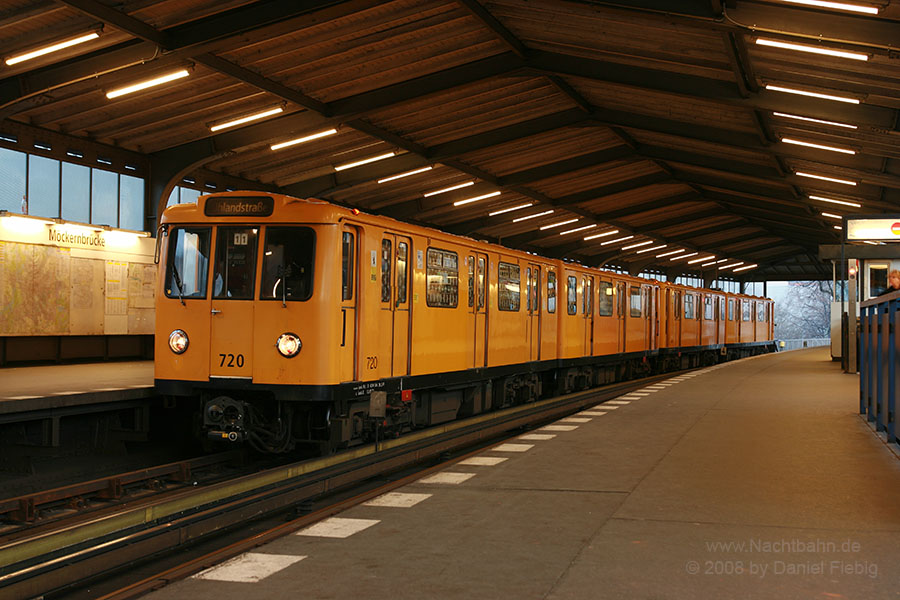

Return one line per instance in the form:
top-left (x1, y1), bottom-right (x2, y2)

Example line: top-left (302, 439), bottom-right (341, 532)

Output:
top-left (859, 292), bottom-right (900, 442)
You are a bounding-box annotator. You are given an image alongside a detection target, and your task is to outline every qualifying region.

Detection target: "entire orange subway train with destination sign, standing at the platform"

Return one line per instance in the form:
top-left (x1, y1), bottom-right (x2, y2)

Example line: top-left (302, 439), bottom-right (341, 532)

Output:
top-left (155, 192), bottom-right (774, 453)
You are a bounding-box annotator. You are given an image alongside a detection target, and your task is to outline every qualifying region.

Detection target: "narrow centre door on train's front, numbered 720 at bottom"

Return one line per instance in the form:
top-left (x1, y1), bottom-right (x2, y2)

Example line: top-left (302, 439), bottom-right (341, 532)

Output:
top-left (209, 226), bottom-right (259, 379)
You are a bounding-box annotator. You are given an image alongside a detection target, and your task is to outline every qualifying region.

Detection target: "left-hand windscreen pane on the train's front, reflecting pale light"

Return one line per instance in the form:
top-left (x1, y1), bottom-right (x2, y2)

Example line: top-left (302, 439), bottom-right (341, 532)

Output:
top-left (166, 227), bottom-right (210, 298)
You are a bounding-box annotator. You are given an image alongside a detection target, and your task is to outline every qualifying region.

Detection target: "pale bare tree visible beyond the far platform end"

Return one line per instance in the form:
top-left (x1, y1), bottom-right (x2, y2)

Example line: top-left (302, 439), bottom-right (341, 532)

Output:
top-left (775, 281), bottom-right (834, 339)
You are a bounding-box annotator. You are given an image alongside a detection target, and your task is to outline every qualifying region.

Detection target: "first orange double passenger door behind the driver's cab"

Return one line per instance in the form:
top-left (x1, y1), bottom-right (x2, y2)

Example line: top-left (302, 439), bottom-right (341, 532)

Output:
top-left (381, 233), bottom-right (412, 377)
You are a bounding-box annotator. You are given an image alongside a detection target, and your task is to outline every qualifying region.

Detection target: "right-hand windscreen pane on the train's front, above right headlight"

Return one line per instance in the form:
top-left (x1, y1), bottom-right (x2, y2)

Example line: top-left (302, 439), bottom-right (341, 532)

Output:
top-left (259, 226), bottom-right (316, 300)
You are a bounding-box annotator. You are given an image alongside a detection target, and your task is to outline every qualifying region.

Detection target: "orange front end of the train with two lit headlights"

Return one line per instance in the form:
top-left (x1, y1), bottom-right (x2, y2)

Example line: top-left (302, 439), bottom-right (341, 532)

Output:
top-left (155, 192), bottom-right (345, 452)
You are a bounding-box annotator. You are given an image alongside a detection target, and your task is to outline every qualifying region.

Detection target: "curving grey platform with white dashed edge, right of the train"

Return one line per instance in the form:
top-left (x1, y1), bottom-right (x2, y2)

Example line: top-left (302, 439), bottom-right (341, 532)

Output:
top-left (147, 348), bottom-right (900, 600)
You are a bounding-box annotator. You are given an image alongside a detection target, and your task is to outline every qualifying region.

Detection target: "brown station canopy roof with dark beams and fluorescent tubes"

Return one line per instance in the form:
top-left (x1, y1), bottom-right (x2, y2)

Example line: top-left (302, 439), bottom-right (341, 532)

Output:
top-left (0, 0), bottom-right (900, 279)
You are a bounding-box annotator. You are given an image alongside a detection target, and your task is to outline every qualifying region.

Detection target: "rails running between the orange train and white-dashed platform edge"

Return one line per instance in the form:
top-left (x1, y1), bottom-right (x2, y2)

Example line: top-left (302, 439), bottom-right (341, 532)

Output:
top-left (0, 374), bottom-right (672, 600)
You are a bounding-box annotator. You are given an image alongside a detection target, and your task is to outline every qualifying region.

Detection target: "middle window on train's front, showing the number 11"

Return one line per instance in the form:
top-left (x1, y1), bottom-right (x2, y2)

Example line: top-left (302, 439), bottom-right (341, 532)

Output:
top-left (213, 227), bottom-right (259, 300)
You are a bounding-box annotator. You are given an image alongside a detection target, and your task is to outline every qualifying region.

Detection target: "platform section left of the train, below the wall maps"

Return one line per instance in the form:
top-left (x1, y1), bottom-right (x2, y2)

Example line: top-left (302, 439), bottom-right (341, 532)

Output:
top-left (0, 360), bottom-right (154, 417)
